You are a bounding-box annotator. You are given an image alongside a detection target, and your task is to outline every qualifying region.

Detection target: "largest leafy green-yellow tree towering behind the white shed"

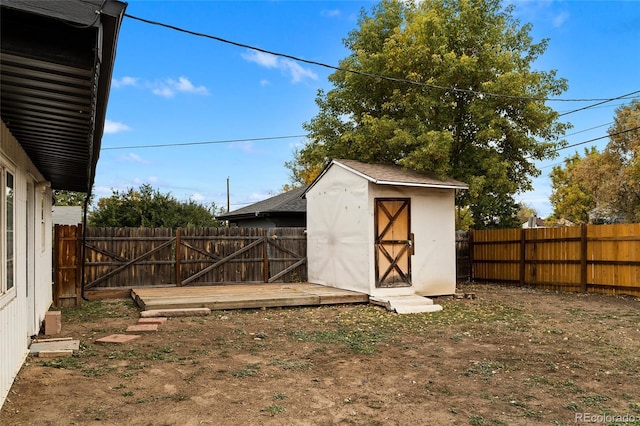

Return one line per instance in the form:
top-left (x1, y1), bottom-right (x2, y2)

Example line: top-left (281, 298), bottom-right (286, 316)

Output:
top-left (287, 0), bottom-right (567, 228)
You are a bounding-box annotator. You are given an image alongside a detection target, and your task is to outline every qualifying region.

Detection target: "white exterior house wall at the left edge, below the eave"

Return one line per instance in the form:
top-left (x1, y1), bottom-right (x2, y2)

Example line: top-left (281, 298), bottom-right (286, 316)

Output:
top-left (0, 121), bottom-right (52, 406)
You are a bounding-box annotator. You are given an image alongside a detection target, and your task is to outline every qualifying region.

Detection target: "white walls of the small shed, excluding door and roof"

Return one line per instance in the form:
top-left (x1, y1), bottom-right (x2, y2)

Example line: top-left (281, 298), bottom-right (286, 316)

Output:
top-left (306, 161), bottom-right (456, 297)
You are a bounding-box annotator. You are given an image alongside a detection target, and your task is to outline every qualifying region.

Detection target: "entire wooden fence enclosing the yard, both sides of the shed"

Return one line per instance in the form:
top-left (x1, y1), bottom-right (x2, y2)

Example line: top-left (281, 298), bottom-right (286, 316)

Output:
top-left (54, 224), bottom-right (640, 306)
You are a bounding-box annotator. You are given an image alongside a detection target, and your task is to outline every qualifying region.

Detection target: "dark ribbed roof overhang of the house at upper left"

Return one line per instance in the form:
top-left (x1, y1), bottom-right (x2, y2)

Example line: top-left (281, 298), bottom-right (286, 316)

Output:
top-left (0, 0), bottom-right (127, 193)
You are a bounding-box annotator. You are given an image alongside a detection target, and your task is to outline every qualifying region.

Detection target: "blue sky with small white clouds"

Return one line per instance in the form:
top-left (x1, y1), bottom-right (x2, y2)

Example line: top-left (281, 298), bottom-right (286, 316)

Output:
top-left (94, 1), bottom-right (640, 217)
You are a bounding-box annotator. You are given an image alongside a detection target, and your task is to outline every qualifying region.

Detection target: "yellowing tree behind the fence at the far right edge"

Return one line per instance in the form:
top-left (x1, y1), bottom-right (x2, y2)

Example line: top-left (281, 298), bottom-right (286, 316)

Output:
top-left (550, 100), bottom-right (640, 223)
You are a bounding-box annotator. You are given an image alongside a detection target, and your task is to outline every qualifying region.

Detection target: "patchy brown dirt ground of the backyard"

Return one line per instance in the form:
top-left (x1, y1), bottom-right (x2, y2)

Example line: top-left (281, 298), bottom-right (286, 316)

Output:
top-left (0, 284), bottom-right (640, 425)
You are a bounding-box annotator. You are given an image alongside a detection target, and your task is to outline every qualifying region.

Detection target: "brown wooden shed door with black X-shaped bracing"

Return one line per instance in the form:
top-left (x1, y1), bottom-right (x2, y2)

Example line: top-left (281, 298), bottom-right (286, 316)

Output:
top-left (375, 198), bottom-right (413, 287)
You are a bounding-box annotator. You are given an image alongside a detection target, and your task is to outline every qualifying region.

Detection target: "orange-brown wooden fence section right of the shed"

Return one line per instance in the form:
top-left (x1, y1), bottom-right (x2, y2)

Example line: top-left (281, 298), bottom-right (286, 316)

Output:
top-left (470, 224), bottom-right (640, 296)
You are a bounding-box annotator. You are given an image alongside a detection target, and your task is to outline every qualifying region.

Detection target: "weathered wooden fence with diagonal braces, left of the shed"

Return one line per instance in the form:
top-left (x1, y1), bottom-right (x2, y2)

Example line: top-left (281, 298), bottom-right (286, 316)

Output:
top-left (54, 225), bottom-right (307, 306)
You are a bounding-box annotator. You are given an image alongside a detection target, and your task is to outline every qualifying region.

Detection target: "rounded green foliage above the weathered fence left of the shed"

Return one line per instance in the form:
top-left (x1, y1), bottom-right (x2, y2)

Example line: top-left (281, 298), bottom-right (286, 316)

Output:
top-left (88, 184), bottom-right (222, 229)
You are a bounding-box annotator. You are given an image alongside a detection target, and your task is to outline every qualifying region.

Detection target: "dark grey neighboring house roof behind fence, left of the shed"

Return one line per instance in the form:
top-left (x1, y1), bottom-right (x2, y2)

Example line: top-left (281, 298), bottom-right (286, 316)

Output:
top-left (216, 186), bottom-right (307, 220)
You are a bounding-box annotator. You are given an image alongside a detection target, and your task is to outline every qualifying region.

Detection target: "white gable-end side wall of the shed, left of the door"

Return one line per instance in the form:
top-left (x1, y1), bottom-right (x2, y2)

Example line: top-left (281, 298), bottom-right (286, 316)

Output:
top-left (306, 167), bottom-right (373, 294)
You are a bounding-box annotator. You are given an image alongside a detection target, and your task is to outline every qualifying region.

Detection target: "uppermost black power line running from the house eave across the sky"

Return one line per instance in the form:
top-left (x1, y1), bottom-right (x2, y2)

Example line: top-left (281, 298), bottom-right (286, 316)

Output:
top-left (124, 13), bottom-right (640, 102)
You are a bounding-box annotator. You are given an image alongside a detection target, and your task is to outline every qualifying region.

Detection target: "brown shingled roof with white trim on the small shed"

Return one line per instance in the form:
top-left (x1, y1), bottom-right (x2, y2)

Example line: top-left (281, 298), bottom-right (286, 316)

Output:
top-left (307, 160), bottom-right (469, 195)
